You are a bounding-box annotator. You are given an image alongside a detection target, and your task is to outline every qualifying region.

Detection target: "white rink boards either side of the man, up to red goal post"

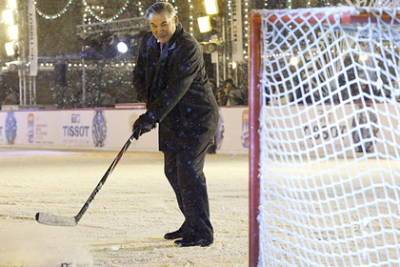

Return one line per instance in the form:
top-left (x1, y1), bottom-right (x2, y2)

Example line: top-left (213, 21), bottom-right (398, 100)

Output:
top-left (0, 107), bottom-right (248, 154)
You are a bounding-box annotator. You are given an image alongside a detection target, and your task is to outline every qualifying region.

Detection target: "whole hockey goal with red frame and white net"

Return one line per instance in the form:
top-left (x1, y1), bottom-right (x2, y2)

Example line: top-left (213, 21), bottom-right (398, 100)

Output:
top-left (249, 7), bottom-right (400, 266)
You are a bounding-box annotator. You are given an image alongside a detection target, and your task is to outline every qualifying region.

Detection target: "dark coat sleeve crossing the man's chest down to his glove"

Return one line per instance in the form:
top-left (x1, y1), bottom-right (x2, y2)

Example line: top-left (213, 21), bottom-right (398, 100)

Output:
top-left (148, 43), bottom-right (202, 122)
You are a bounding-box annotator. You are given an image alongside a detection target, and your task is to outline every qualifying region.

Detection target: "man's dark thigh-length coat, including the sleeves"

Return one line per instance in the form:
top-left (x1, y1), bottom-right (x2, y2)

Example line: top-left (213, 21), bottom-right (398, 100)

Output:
top-left (134, 24), bottom-right (218, 151)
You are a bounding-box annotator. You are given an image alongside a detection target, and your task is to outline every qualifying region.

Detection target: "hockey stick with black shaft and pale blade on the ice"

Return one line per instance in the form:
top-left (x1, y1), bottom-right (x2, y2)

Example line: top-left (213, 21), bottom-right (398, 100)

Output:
top-left (35, 134), bottom-right (134, 226)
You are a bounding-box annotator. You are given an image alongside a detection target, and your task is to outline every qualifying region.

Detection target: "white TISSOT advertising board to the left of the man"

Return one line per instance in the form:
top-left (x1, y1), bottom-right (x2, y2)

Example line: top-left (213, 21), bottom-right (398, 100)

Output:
top-left (0, 109), bottom-right (158, 151)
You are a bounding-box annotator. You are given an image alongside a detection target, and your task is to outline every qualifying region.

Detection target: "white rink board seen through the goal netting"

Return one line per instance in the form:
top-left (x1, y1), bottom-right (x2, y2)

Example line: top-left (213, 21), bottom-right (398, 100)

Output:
top-left (265, 103), bottom-right (400, 158)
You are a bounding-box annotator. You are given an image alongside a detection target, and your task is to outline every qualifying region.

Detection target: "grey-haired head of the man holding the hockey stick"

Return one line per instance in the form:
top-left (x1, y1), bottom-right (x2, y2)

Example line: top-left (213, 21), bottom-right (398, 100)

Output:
top-left (145, 2), bottom-right (178, 44)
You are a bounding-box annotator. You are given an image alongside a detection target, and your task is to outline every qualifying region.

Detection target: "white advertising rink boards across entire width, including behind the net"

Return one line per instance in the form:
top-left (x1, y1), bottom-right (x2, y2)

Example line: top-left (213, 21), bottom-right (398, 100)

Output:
top-left (0, 104), bottom-right (400, 157)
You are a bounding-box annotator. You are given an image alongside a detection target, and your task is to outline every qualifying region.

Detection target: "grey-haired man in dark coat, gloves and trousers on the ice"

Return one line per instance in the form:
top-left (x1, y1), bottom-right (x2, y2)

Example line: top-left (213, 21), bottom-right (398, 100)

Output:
top-left (133, 2), bottom-right (218, 247)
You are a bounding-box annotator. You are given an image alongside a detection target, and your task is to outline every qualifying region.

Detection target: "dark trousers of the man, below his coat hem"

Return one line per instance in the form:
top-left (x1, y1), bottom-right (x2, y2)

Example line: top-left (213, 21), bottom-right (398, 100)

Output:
top-left (163, 143), bottom-right (213, 239)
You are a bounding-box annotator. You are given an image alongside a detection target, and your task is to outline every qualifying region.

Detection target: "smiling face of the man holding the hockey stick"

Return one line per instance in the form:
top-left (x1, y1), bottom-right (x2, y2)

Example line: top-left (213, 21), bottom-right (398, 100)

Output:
top-left (149, 12), bottom-right (177, 44)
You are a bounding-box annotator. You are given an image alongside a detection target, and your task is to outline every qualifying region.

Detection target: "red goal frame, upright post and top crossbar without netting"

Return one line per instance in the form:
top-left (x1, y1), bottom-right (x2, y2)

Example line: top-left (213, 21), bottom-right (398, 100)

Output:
top-left (248, 6), bottom-right (400, 267)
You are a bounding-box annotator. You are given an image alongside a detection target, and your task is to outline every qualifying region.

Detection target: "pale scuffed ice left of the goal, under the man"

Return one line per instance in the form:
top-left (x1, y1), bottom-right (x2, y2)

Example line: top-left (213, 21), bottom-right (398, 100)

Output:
top-left (0, 147), bottom-right (248, 267)
